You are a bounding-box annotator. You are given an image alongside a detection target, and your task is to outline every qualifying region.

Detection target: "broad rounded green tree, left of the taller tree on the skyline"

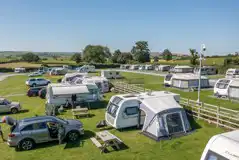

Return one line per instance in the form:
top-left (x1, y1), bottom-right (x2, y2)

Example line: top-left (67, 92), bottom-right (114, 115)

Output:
top-left (83, 45), bottom-right (111, 63)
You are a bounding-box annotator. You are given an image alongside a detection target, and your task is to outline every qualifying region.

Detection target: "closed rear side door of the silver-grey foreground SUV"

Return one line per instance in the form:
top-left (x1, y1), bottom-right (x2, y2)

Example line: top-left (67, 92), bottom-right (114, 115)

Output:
top-left (32, 122), bottom-right (50, 143)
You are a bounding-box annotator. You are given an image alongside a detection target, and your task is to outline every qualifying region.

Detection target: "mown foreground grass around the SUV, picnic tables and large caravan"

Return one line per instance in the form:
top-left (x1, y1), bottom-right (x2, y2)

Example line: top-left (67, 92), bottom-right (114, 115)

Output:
top-left (0, 74), bottom-right (224, 160)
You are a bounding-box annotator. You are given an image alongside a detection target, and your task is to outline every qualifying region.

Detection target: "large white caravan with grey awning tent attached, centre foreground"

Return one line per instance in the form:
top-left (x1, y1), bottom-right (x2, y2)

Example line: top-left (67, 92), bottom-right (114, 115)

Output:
top-left (105, 91), bottom-right (190, 140)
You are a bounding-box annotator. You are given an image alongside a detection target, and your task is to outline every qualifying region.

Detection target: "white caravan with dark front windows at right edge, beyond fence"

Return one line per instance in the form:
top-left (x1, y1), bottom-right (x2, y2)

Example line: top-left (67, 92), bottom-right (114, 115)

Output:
top-left (214, 78), bottom-right (239, 97)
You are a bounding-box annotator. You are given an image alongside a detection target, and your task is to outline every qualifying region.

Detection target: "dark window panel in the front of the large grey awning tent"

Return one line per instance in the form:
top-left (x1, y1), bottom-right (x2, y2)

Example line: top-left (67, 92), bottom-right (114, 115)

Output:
top-left (166, 113), bottom-right (184, 134)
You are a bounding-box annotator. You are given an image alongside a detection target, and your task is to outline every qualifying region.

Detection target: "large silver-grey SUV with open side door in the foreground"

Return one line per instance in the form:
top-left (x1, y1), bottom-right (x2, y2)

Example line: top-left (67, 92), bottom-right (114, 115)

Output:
top-left (8, 116), bottom-right (84, 150)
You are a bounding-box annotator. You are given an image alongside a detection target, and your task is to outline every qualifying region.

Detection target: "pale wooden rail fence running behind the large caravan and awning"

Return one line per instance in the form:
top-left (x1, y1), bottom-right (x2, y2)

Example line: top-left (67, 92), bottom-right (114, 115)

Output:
top-left (112, 81), bottom-right (239, 130)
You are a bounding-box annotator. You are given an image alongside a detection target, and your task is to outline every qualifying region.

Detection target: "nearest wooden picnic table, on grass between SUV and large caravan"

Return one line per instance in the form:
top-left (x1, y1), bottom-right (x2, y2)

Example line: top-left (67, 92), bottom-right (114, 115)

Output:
top-left (91, 131), bottom-right (122, 153)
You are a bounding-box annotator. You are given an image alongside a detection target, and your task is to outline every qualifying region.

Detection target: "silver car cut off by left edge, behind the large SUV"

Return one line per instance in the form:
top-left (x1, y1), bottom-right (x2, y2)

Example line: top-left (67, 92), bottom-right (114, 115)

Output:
top-left (0, 98), bottom-right (21, 114)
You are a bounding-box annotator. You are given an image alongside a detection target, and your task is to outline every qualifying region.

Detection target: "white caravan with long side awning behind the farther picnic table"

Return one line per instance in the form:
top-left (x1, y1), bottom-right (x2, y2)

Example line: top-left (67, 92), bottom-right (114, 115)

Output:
top-left (46, 83), bottom-right (102, 106)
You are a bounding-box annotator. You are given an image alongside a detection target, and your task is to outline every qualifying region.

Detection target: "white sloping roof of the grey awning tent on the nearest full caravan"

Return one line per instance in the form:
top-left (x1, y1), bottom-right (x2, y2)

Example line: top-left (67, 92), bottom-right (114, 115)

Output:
top-left (141, 96), bottom-right (182, 114)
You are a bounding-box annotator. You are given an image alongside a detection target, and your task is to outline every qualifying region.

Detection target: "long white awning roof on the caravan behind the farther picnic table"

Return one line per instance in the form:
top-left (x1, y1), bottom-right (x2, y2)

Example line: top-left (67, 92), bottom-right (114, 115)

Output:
top-left (52, 85), bottom-right (89, 95)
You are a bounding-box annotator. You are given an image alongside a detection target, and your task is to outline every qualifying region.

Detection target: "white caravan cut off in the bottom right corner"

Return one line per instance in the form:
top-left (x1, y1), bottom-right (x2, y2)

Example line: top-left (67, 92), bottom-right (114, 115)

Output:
top-left (200, 130), bottom-right (239, 160)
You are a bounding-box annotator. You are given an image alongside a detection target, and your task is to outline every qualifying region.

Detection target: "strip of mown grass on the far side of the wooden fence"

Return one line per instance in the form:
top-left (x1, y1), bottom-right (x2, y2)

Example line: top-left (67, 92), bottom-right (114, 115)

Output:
top-left (121, 72), bottom-right (239, 110)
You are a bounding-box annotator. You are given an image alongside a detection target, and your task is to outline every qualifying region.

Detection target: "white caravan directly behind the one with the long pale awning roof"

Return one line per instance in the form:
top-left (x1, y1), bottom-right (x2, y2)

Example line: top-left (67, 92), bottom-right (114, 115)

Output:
top-left (71, 76), bottom-right (110, 93)
